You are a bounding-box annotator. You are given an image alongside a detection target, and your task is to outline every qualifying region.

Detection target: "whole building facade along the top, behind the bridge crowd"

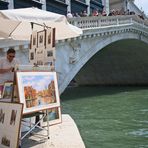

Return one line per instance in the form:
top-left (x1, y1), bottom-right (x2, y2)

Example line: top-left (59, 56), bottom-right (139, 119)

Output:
top-left (0, 0), bottom-right (141, 15)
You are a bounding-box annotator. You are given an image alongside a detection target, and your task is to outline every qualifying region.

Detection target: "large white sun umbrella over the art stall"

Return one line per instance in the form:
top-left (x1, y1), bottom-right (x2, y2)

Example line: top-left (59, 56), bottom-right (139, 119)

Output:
top-left (0, 8), bottom-right (82, 40)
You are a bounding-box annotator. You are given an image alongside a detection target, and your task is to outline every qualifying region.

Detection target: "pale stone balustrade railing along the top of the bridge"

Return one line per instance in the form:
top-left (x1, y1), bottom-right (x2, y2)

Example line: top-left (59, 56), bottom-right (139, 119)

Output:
top-left (68, 15), bottom-right (148, 29)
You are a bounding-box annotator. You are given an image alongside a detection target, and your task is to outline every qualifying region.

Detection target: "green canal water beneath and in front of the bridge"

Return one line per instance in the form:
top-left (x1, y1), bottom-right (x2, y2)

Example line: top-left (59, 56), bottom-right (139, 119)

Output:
top-left (61, 86), bottom-right (148, 148)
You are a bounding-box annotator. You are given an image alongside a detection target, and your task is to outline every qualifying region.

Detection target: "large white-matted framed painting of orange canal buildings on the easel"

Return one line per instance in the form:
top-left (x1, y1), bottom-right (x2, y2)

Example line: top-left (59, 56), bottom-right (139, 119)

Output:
top-left (16, 71), bottom-right (60, 114)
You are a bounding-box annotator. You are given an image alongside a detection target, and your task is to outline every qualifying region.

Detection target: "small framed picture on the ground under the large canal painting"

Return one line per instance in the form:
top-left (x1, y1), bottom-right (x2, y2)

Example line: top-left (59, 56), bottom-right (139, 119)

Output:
top-left (43, 107), bottom-right (62, 126)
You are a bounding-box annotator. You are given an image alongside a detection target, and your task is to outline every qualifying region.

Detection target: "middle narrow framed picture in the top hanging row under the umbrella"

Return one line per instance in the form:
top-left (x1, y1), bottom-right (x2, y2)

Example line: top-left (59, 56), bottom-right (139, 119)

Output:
top-left (37, 30), bottom-right (45, 48)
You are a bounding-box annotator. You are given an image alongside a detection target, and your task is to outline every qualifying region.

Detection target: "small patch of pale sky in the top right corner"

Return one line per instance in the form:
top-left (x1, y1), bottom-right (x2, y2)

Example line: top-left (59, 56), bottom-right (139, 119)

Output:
top-left (135, 0), bottom-right (148, 15)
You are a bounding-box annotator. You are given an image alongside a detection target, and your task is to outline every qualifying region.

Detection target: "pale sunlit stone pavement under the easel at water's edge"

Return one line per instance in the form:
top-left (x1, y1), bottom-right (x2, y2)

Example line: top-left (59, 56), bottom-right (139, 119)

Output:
top-left (22, 114), bottom-right (85, 148)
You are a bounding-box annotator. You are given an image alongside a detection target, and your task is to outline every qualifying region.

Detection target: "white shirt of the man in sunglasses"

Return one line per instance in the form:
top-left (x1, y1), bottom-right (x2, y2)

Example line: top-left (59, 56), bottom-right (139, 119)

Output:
top-left (0, 57), bottom-right (19, 84)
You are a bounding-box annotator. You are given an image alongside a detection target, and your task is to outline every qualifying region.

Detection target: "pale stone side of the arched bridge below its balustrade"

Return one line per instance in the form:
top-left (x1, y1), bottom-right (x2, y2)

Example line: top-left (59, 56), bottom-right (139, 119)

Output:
top-left (56, 25), bottom-right (148, 93)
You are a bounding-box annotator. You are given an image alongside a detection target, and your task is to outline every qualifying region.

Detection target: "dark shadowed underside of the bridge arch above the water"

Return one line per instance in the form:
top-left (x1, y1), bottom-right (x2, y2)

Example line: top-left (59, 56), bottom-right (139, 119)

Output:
top-left (74, 39), bottom-right (148, 86)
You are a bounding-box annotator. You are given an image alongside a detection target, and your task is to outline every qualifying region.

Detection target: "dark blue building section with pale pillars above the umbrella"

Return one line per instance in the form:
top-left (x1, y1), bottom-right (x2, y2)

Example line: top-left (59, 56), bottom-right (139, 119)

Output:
top-left (0, 0), bottom-right (104, 15)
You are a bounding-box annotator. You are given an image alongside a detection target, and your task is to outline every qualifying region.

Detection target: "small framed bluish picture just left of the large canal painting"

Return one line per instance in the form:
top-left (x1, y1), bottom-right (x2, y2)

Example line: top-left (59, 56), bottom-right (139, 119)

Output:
top-left (2, 82), bottom-right (13, 99)
